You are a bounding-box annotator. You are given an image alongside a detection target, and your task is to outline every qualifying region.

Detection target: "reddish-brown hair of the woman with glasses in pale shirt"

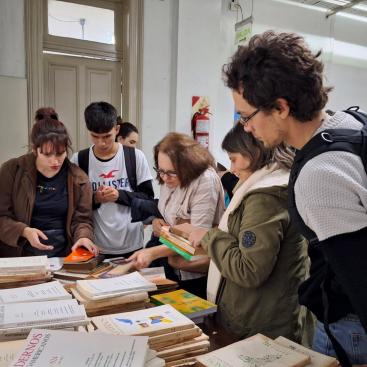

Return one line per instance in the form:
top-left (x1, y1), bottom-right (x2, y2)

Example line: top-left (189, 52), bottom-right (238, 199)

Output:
top-left (154, 133), bottom-right (215, 187)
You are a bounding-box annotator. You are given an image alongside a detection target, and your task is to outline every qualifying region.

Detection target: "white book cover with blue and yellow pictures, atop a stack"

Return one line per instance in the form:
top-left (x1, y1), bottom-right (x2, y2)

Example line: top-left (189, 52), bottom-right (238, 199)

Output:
top-left (92, 305), bottom-right (195, 335)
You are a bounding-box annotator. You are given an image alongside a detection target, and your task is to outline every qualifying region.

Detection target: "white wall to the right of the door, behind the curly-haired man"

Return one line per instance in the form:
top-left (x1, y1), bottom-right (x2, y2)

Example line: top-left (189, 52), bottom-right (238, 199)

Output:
top-left (142, 0), bottom-right (367, 164)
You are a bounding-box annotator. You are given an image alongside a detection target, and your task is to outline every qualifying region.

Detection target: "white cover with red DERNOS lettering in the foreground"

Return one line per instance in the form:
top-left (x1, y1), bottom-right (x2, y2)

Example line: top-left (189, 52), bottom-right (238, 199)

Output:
top-left (9, 329), bottom-right (148, 367)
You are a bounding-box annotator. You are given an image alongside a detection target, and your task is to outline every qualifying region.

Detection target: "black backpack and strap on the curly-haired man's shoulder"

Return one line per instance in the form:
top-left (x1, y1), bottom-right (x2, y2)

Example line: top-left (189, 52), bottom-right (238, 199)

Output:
top-left (288, 106), bottom-right (367, 367)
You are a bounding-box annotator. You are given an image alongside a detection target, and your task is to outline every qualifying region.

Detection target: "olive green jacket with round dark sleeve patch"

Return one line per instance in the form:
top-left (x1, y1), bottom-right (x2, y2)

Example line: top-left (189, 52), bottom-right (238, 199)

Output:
top-left (201, 186), bottom-right (307, 341)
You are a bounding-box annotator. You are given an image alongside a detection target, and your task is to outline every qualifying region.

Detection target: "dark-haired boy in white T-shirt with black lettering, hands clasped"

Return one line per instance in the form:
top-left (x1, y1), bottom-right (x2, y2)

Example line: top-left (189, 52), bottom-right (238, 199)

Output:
top-left (71, 102), bottom-right (154, 257)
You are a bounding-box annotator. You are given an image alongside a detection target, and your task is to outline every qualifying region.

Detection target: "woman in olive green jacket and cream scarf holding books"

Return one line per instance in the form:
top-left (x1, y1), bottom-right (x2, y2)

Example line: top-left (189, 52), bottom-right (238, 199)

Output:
top-left (190, 123), bottom-right (307, 342)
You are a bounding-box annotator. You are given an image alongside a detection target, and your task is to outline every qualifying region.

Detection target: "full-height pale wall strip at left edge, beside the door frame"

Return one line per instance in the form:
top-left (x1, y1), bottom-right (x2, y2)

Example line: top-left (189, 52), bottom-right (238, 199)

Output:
top-left (0, 0), bottom-right (28, 164)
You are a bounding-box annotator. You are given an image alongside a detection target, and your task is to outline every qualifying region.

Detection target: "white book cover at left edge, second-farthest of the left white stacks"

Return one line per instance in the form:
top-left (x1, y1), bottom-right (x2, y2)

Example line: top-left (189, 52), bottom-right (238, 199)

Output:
top-left (0, 281), bottom-right (71, 304)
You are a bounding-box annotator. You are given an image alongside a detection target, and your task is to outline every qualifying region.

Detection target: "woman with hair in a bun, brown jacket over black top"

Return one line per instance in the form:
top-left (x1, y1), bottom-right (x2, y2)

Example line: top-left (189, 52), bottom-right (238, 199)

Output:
top-left (0, 116), bottom-right (98, 257)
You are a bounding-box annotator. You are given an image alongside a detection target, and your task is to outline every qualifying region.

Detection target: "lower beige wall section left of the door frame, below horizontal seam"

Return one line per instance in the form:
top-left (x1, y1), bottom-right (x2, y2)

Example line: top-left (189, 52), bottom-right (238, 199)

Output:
top-left (0, 76), bottom-right (28, 164)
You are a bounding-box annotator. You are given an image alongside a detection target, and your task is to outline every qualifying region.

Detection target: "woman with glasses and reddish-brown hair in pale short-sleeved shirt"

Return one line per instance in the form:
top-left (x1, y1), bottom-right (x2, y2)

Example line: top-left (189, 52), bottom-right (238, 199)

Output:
top-left (130, 133), bottom-right (224, 297)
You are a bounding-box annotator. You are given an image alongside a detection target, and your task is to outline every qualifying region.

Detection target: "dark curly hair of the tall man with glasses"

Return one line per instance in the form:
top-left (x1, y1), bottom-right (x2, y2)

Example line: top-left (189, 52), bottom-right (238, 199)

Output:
top-left (222, 31), bottom-right (332, 122)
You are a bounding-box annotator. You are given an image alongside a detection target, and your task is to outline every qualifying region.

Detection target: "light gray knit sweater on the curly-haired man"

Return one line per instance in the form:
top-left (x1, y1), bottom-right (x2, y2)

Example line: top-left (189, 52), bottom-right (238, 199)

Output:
top-left (294, 112), bottom-right (367, 241)
